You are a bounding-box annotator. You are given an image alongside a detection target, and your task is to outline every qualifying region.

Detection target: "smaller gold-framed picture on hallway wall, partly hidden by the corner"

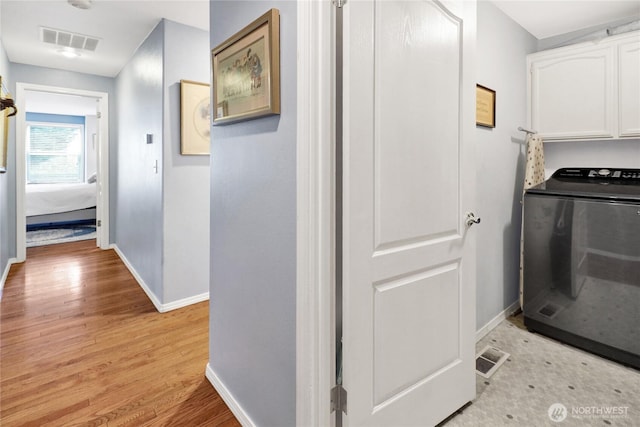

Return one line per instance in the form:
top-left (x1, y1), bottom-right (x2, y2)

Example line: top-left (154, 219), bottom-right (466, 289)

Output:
top-left (180, 80), bottom-right (211, 156)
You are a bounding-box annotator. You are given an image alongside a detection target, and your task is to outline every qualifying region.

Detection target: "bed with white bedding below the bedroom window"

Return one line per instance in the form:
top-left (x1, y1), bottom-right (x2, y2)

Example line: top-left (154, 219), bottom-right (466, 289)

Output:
top-left (25, 182), bottom-right (96, 226)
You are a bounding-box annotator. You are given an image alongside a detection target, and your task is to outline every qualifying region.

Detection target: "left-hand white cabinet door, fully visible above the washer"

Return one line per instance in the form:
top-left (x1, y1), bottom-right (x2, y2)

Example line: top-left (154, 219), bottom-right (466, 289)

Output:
top-left (531, 47), bottom-right (615, 139)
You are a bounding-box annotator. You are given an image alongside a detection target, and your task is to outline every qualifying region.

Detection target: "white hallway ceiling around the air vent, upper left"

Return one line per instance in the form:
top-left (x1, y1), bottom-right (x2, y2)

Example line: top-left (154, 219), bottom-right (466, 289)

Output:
top-left (0, 0), bottom-right (209, 77)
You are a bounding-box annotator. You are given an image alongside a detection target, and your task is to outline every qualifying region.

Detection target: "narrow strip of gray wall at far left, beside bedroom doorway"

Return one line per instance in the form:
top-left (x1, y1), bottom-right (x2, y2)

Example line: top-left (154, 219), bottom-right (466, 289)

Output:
top-left (0, 40), bottom-right (11, 278)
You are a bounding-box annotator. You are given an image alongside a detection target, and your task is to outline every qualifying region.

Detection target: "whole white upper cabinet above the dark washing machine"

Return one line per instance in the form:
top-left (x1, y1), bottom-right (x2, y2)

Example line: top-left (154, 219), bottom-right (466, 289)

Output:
top-left (527, 31), bottom-right (640, 140)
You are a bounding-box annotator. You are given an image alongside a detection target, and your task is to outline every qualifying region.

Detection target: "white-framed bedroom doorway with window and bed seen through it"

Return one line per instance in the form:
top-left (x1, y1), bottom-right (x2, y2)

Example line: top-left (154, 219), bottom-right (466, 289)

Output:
top-left (16, 83), bottom-right (109, 262)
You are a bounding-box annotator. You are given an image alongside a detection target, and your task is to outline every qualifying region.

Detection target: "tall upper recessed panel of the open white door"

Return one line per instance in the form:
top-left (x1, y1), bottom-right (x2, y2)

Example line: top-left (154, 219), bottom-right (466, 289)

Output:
top-left (374, 1), bottom-right (461, 248)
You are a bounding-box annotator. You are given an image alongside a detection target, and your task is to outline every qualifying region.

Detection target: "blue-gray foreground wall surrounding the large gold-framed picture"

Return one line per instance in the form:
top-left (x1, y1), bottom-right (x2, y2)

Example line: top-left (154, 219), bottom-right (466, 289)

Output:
top-left (209, 1), bottom-right (297, 426)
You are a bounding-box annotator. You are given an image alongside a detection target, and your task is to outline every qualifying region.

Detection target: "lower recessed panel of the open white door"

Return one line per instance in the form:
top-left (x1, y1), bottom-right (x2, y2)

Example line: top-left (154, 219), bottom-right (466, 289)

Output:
top-left (373, 264), bottom-right (460, 409)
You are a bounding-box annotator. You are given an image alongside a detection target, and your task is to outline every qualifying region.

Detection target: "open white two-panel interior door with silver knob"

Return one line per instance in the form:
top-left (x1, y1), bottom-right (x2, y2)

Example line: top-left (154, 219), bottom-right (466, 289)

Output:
top-left (343, 0), bottom-right (476, 426)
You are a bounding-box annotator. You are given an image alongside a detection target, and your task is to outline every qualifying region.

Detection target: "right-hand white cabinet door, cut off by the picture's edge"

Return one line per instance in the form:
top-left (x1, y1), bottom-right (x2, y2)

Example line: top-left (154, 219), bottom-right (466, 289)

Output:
top-left (618, 40), bottom-right (640, 136)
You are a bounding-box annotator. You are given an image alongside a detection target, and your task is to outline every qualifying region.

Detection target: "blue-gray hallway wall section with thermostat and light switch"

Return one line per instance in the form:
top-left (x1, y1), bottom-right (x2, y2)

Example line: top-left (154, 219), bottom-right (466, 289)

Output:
top-left (114, 22), bottom-right (164, 301)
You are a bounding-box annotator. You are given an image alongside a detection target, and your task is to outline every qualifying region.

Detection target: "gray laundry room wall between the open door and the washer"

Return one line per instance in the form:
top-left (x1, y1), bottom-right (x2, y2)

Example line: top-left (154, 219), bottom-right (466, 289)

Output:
top-left (475, 1), bottom-right (537, 329)
